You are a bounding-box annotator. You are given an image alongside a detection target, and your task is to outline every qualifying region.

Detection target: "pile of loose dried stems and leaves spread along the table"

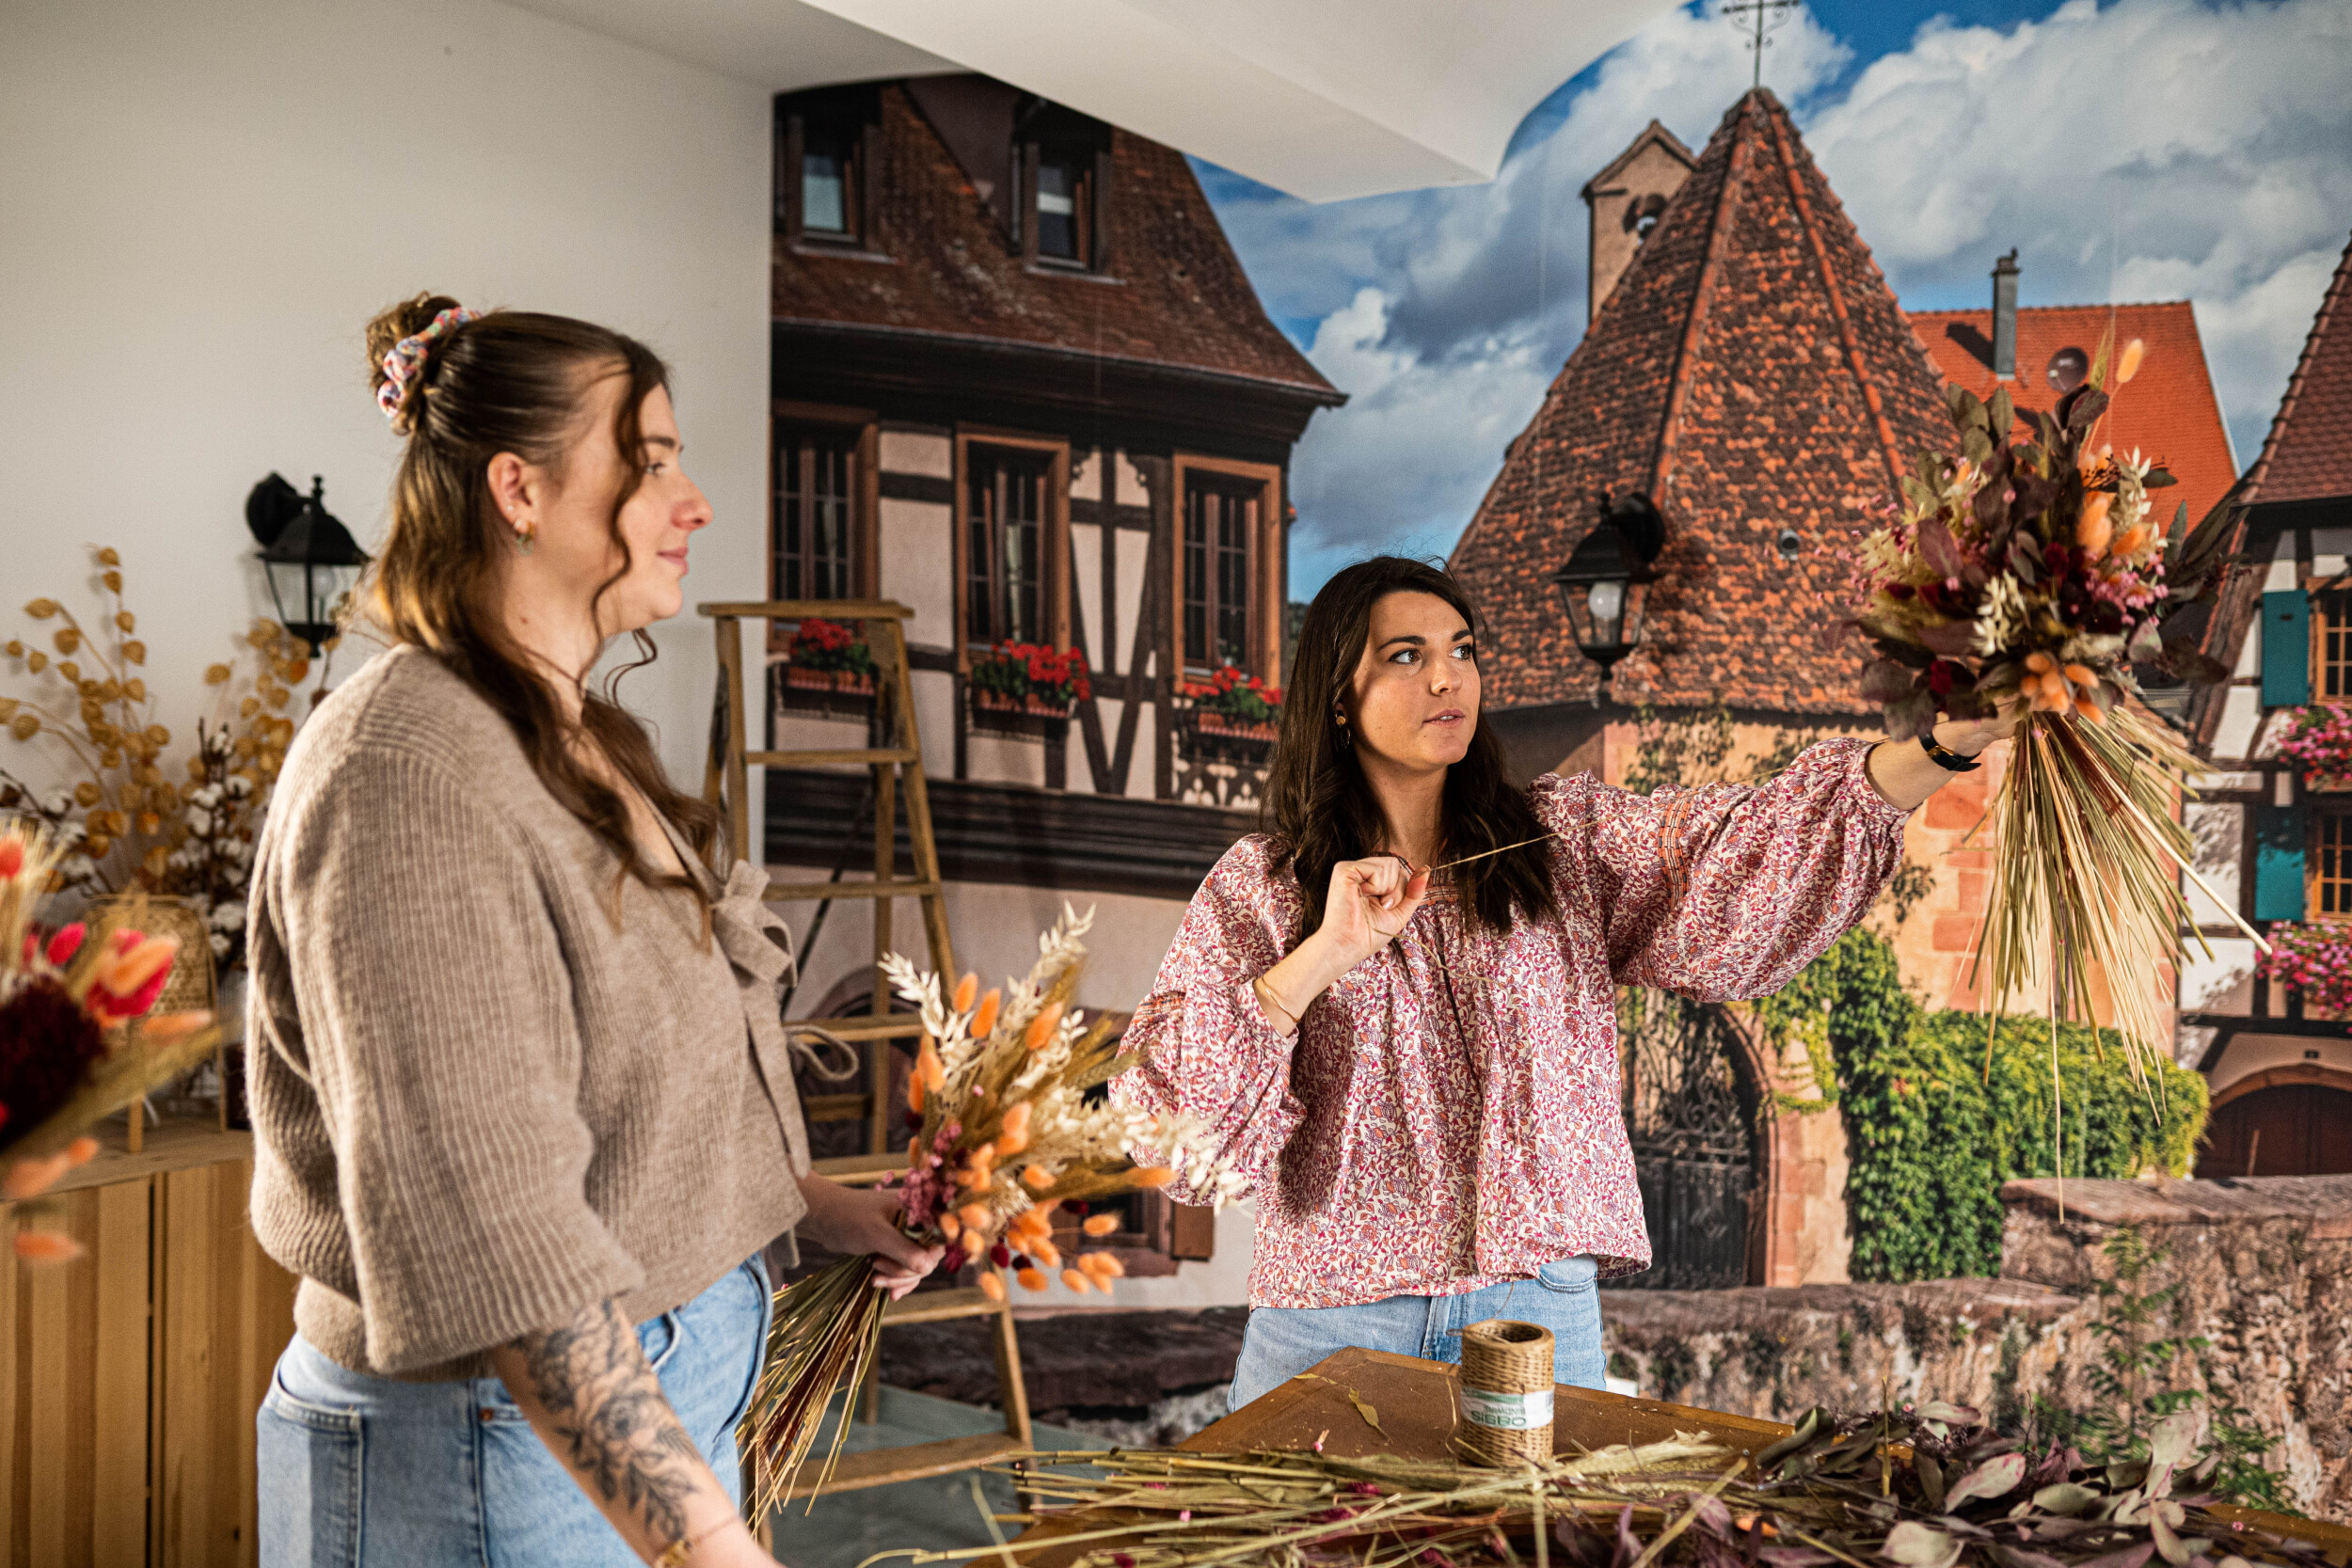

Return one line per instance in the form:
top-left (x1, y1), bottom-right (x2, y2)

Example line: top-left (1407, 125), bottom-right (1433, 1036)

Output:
top-left (866, 1403), bottom-right (2324, 1568)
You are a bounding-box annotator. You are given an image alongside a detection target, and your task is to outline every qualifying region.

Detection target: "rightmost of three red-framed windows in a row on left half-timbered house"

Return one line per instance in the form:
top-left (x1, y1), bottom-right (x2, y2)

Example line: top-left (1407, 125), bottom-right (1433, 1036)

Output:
top-left (1174, 456), bottom-right (1282, 684)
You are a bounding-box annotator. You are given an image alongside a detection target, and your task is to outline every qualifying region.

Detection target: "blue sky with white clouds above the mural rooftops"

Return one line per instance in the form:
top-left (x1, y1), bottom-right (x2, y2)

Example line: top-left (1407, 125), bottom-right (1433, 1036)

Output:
top-left (1200, 0), bottom-right (2352, 597)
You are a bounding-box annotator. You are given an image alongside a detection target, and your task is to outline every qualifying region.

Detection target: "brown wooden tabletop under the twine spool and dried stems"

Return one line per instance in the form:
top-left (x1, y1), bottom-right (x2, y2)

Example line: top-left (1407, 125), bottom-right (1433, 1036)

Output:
top-left (1019, 1350), bottom-right (2352, 1568)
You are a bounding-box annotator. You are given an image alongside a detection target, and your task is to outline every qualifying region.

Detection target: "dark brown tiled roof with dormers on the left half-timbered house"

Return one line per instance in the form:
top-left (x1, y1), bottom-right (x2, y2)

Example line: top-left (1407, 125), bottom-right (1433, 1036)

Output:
top-left (771, 87), bottom-right (1341, 402)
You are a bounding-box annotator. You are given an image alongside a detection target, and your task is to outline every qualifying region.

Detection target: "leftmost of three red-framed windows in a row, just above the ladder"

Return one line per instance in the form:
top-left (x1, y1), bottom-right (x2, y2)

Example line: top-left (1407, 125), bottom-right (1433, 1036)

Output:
top-left (767, 402), bottom-right (878, 640)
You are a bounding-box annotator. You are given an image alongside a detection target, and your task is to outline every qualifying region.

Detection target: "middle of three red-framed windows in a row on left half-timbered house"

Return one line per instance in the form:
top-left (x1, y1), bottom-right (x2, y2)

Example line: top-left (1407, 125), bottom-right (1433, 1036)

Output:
top-left (955, 435), bottom-right (1071, 649)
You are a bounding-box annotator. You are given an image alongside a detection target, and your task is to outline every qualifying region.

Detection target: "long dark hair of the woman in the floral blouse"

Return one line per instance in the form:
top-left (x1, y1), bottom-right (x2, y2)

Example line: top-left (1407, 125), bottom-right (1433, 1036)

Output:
top-left (1259, 555), bottom-right (1560, 936)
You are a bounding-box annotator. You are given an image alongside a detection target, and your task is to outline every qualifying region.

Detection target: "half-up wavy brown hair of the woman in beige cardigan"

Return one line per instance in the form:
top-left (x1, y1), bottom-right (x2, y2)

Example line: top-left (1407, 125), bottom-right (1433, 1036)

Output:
top-left (367, 293), bottom-right (720, 898)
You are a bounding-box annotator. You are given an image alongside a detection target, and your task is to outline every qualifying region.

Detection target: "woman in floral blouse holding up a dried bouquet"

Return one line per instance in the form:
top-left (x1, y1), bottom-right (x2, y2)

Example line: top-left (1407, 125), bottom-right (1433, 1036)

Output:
top-left (1115, 557), bottom-right (2009, 1408)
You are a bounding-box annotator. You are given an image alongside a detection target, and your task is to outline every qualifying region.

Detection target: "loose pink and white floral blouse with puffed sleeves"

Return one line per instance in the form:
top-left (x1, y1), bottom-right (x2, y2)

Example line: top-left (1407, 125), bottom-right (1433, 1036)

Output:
top-left (1113, 740), bottom-right (1908, 1307)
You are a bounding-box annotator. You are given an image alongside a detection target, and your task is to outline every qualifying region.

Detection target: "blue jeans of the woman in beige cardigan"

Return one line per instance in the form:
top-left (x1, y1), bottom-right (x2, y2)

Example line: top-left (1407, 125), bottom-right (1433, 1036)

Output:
top-left (257, 1258), bottom-right (770, 1568)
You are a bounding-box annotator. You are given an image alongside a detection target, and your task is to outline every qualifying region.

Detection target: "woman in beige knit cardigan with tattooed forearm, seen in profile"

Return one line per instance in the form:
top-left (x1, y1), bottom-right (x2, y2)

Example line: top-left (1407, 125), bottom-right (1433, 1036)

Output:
top-left (249, 293), bottom-right (939, 1568)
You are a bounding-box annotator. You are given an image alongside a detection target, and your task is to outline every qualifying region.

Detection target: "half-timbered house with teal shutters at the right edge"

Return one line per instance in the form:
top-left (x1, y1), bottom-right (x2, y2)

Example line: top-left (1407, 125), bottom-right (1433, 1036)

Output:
top-left (2164, 227), bottom-right (2352, 1176)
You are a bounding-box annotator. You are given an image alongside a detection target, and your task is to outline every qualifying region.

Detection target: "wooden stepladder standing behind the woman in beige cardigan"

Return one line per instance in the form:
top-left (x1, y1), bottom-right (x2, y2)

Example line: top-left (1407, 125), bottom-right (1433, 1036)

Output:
top-left (696, 599), bottom-right (1030, 1544)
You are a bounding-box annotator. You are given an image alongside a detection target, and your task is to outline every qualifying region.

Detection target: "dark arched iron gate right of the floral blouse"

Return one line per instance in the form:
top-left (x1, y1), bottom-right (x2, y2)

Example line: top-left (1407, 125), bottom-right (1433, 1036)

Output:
top-left (1618, 990), bottom-right (1755, 1291)
